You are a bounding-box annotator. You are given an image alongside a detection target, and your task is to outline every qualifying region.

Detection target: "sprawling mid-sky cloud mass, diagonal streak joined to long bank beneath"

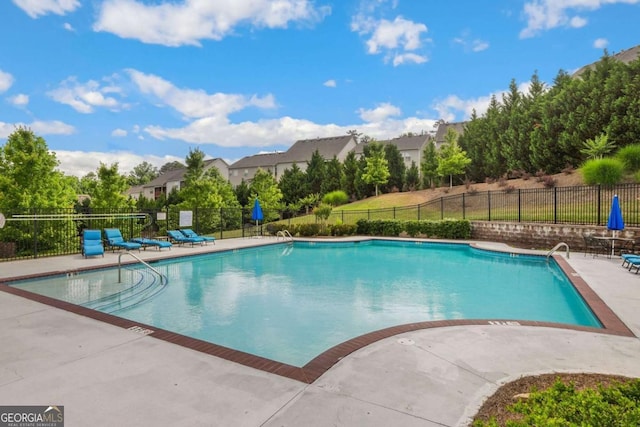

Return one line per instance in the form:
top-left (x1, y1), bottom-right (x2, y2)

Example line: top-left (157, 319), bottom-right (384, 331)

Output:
top-left (121, 70), bottom-right (435, 147)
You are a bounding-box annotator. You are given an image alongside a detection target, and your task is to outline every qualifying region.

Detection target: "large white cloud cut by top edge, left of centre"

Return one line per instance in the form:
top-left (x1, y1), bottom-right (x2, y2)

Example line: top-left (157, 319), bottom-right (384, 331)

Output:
top-left (93, 0), bottom-right (331, 46)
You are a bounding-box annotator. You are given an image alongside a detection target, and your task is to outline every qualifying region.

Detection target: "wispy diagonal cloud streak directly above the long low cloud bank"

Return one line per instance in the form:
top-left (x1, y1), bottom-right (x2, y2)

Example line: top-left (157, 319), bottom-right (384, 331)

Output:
top-left (127, 69), bottom-right (276, 120)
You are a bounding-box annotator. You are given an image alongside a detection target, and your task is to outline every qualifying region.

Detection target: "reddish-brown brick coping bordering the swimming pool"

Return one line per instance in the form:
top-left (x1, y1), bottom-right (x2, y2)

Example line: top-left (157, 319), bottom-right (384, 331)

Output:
top-left (0, 237), bottom-right (635, 384)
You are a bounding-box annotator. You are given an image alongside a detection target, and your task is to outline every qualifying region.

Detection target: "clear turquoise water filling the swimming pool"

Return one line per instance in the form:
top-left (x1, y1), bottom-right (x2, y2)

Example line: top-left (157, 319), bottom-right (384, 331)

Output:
top-left (10, 241), bottom-right (601, 366)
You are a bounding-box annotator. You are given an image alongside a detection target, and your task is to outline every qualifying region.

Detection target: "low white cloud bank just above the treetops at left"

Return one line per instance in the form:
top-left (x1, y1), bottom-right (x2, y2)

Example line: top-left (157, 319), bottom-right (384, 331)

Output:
top-left (53, 150), bottom-right (184, 177)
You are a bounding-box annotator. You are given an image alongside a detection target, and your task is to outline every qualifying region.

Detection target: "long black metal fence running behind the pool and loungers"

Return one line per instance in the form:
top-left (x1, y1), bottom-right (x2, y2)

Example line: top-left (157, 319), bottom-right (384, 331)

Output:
top-left (0, 184), bottom-right (640, 261)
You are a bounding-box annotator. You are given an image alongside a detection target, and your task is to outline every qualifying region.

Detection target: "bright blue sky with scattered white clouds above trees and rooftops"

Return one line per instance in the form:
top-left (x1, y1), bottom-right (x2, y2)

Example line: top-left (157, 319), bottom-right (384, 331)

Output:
top-left (0, 0), bottom-right (640, 176)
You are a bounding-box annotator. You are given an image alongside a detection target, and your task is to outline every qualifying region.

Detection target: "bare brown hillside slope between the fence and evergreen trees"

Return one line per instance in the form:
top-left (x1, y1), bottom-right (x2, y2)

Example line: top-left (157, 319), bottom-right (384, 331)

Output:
top-left (335, 171), bottom-right (584, 210)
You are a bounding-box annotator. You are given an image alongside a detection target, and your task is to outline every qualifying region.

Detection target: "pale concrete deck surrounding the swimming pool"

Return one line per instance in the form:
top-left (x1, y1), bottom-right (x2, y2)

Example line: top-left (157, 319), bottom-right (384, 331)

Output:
top-left (0, 239), bottom-right (640, 426)
